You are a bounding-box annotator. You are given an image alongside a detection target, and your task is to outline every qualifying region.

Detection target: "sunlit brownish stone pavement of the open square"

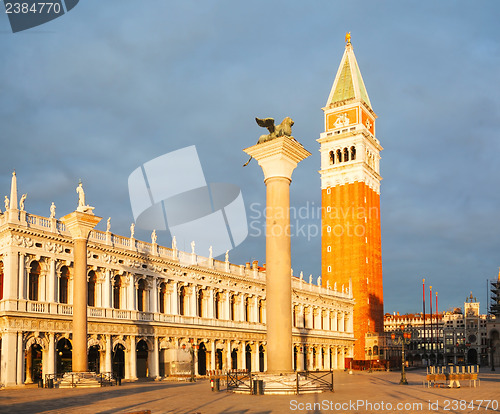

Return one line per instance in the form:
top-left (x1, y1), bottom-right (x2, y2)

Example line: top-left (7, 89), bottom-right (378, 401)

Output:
top-left (0, 368), bottom-right (500, 414)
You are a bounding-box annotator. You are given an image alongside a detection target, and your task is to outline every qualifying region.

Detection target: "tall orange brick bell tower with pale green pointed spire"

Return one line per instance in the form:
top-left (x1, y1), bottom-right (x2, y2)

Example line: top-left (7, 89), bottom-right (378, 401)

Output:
top-left (318, 33), bottom-right (384, 360)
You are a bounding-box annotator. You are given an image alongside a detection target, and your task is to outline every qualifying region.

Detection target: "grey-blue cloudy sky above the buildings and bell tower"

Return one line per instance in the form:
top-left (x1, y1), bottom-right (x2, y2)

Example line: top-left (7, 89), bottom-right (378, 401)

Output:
top-left (0, 0), bottom-right (500, 313)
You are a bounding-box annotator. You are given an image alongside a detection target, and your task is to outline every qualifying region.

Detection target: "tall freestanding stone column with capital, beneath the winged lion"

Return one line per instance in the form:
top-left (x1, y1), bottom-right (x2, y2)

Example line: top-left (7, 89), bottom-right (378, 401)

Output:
top-left (244, 136), bottom-right (311, 374)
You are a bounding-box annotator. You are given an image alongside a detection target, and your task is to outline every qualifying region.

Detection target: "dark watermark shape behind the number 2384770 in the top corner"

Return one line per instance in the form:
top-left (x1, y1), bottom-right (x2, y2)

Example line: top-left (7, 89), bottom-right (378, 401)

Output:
top-left (3, 0), bottom-right (80, 33)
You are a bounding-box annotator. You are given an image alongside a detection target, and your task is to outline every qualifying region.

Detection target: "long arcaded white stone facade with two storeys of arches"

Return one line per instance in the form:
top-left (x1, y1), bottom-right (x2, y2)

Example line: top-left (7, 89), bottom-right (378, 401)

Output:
top-left (0, 183), bottom-right (355, 386)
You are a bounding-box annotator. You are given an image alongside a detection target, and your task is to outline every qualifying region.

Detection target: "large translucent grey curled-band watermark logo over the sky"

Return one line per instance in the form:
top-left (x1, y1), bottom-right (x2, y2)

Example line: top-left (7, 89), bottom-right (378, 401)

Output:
top-left (128, 145), bottom-right (248, 257)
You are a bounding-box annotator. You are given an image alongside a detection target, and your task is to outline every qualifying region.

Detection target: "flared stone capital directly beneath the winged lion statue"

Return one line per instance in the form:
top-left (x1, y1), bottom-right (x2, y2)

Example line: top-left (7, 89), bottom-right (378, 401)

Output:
top-left (243, 136), bottom-right (311, 180)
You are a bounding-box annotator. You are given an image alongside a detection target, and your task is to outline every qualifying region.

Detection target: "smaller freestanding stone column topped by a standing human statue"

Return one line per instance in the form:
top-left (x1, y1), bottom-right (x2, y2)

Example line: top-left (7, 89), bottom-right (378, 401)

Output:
top-left (61, 211), bottom-right (101, 372)
